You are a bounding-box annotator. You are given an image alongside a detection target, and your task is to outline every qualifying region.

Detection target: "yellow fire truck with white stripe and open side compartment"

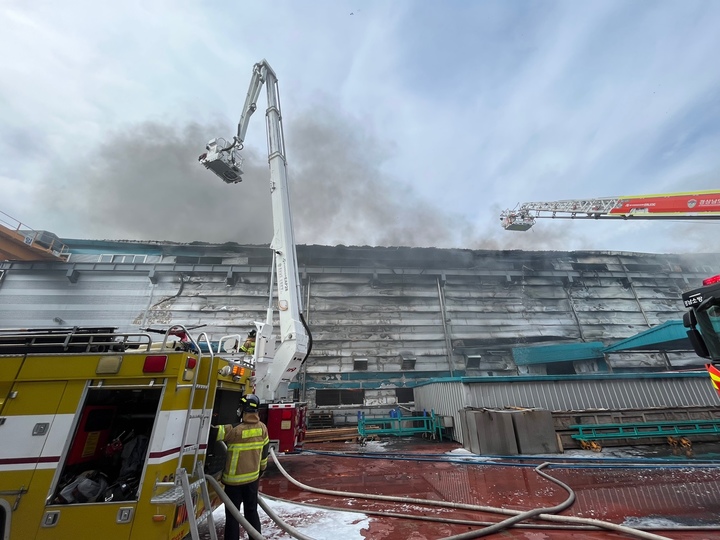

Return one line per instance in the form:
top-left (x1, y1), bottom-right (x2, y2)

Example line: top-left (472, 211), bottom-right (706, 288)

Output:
top-left (0, 326), bottom-right (254, 540)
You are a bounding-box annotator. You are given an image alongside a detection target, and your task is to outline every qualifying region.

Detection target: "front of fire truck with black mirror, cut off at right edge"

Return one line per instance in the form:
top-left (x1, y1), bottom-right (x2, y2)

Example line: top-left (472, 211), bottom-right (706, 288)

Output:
top-left (682, 275), bottom-right (720, 394)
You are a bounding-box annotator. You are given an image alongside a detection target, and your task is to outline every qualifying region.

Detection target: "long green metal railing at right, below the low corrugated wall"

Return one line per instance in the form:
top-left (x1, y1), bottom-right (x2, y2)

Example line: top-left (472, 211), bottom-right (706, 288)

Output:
top-left (568, 419), bottom-right (720, 441)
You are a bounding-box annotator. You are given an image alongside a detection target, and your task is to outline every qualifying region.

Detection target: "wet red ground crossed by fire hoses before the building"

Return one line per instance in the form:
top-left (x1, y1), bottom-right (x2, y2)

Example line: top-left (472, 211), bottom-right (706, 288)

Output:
top-left (205, 439), bottom-right (720, 540)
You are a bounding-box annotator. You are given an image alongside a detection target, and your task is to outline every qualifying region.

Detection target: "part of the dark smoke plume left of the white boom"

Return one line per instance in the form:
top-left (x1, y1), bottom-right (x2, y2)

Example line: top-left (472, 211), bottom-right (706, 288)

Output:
top-left (43, 122), bottom-right (272, 244)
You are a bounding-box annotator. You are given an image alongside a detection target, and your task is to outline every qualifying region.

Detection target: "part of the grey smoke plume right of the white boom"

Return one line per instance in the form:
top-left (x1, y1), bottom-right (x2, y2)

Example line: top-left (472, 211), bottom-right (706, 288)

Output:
top-left (287, 110), bottom-right (567, 249)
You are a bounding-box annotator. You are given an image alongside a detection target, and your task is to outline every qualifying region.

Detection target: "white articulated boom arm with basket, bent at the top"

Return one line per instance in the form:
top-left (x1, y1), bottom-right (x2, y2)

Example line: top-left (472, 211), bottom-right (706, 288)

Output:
top-left (199, 60), bottom-right (310, 401)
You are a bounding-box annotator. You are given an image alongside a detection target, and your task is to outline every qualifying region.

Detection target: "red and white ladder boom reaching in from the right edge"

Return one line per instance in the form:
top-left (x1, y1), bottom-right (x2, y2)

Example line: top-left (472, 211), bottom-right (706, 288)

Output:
top-left (500, 190), bottom-right (720, 231)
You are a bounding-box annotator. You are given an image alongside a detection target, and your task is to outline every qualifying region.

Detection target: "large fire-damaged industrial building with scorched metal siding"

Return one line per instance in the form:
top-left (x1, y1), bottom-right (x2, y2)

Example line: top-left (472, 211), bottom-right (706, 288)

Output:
top-left (0, 239), bottom-right (720, 422)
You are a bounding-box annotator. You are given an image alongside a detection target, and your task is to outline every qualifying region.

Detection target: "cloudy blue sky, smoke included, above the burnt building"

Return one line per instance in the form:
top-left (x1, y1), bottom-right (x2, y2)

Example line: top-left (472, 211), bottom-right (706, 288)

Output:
top-left (0, 0), bottom-right (720, 253)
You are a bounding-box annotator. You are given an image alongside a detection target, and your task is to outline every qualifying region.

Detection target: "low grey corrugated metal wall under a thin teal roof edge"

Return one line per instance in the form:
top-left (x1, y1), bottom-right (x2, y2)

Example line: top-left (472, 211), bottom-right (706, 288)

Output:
top-left (414, 373), bottom-right (720, 448)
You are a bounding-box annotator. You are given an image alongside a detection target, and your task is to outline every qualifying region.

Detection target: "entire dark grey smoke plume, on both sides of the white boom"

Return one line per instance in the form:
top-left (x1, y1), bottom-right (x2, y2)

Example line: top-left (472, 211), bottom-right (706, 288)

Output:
top-left (39, 108), bottom-right (584, 249)
